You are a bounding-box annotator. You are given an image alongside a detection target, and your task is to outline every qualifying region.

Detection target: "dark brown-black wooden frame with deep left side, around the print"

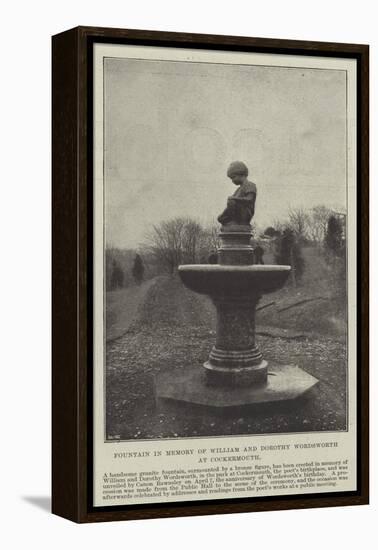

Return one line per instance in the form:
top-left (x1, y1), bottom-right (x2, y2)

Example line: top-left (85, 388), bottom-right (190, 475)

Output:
top-left (52, 27), bottom-right (369, 523)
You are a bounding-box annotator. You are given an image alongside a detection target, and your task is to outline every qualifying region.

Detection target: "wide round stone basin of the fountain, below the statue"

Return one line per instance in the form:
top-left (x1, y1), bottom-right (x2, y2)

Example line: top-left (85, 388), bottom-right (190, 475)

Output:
top-left (178, 264), bottom-right (291, 296)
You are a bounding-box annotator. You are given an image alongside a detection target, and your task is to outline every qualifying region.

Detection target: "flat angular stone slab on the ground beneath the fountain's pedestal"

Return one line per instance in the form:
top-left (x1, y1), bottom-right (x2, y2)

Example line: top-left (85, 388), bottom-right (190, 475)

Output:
top-left (155, 365), bottom-right (318, 412)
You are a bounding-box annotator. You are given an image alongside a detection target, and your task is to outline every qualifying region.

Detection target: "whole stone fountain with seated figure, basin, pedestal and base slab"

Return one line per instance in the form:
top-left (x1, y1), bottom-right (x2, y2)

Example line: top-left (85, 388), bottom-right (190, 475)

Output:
top-left (155, 162), bottom-right (318, 410)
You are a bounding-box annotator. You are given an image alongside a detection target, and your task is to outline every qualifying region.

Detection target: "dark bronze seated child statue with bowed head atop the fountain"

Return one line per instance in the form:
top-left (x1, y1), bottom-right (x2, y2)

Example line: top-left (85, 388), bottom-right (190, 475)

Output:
top-left (218, 161), bottom-right (257, 225)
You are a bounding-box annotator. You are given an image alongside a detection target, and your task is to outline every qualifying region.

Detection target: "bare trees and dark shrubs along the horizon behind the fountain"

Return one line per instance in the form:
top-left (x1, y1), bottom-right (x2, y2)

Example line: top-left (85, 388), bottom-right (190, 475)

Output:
top-left (106, 205), bottom-right (345, 290)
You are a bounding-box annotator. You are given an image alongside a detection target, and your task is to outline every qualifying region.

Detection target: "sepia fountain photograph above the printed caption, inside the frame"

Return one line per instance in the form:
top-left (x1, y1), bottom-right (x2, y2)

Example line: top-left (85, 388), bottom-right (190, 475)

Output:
top-left (95, 48), bottom-right (356, 441)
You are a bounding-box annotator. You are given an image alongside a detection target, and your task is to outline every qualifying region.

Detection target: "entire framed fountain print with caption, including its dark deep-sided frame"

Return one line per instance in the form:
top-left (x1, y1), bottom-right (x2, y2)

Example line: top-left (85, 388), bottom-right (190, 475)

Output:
top-left (52, 27), bottom-right (369, 522)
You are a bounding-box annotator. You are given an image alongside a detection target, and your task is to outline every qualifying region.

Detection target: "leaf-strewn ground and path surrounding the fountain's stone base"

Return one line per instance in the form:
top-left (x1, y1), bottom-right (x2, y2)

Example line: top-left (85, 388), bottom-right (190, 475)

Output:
top-left (106, 277), bottom-right (347, 439)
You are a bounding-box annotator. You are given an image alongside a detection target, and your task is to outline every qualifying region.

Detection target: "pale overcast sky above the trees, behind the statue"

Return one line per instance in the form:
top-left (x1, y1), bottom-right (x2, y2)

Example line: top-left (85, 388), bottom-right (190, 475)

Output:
top-left (104, 55), bottom-right (346, 248)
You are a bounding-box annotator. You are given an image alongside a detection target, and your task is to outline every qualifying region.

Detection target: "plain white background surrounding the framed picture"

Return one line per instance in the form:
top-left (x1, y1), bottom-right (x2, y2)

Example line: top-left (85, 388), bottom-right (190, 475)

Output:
top-left (0, 0), bottom-right (378, 550)
